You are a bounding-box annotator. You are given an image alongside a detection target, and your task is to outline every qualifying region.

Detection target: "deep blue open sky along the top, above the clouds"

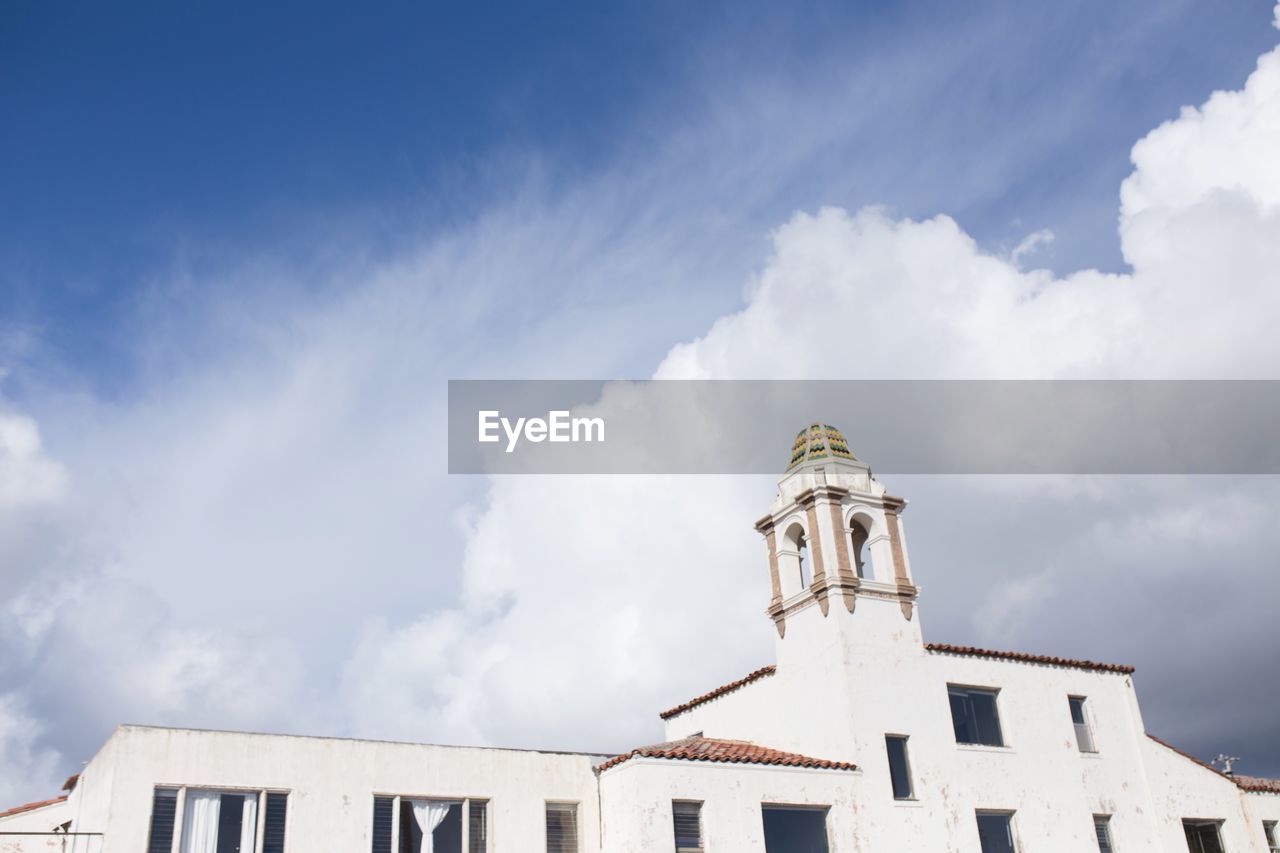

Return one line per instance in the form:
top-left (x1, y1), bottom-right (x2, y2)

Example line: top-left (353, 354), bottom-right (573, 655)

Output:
top-left (0, 1), bottom-right (1270, 393)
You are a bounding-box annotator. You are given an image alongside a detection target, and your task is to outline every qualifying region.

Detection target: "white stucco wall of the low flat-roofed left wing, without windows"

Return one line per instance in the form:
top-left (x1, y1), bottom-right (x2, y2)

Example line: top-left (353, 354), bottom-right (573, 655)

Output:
top-left (68, 726), bottom-right (599, 853)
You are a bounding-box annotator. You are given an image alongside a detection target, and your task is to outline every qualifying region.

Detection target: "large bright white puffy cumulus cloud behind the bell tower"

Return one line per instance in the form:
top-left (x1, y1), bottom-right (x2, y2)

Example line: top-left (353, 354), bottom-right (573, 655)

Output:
top-left (347, 33), bottom-right (1280, 768)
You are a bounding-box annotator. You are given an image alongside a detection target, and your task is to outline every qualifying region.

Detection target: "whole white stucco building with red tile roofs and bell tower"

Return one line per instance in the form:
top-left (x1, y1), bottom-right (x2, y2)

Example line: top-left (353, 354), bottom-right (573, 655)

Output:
top-left (0, 424), bottom-right (1280, 853)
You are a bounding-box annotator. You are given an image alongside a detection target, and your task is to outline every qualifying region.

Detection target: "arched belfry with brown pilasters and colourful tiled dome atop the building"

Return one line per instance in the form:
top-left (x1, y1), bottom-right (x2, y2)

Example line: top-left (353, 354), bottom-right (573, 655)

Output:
top-left (755, 424), bottom-right (920, 642)
